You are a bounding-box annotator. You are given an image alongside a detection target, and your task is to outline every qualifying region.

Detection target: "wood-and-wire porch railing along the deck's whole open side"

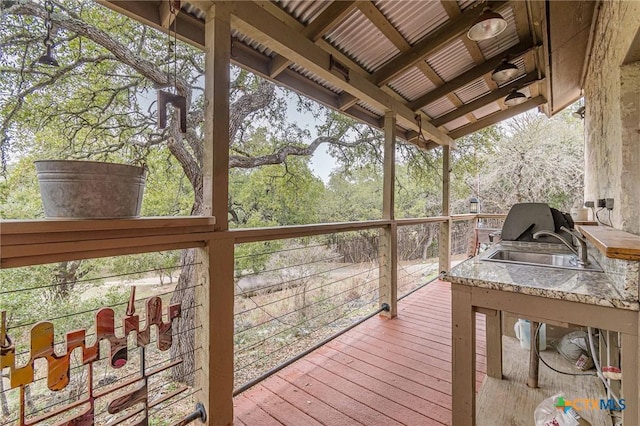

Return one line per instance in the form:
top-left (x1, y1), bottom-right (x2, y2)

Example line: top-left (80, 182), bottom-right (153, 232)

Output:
top-left (0, 215), bottom-right (499, 426)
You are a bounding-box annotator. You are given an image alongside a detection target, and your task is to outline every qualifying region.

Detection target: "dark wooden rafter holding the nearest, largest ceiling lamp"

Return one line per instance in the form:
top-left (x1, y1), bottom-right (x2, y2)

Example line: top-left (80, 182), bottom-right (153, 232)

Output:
top-left (372, 1), bottom-right (506, 86)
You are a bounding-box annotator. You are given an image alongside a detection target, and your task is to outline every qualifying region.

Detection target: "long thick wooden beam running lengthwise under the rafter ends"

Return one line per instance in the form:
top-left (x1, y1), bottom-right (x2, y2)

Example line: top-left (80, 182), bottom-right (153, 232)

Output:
top-left (231, 2), bottom-right (452, 145)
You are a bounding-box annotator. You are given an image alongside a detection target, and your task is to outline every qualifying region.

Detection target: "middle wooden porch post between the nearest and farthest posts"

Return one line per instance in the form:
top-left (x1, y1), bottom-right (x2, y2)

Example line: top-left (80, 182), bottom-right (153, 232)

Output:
top-left (379, 111), bottom-right (398, 318)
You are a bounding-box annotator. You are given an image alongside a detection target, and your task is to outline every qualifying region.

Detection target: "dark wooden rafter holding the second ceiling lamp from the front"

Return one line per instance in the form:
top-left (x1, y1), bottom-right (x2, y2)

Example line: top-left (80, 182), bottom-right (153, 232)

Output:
top-left (408, 41), bottom-right (533, 111)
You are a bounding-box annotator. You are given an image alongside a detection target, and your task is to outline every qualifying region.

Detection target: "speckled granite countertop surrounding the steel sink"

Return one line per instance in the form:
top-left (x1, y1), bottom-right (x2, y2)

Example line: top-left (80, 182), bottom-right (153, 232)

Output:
top-left (444, 241), bottom-right (640, 311)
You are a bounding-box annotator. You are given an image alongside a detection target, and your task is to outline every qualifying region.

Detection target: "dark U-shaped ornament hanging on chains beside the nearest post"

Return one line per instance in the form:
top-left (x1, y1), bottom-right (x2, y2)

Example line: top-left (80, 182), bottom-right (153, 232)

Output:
top-left (158, 0), bottom-right (187, 133)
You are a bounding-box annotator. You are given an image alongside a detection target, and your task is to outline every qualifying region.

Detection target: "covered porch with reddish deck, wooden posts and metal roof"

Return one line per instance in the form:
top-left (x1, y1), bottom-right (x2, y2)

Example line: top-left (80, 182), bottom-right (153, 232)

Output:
top-left (2, 0), bottom-right (640, 426)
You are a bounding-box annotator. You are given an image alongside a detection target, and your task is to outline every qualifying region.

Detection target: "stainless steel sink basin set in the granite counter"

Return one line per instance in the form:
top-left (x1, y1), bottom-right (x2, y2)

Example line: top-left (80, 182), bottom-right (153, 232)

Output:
top-left (482, 249), bottom-right (602, 272)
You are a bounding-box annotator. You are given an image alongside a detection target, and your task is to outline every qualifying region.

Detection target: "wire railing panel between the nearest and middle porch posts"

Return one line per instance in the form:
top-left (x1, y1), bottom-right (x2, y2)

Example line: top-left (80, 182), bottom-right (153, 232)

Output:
top-left (234, 230), bottom-right (381, 388)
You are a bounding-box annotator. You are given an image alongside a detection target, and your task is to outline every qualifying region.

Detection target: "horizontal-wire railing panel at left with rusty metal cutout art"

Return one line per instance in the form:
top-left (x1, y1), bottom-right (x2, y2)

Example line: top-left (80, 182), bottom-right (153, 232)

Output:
top-left (0, 251), bottom-right (203, 426)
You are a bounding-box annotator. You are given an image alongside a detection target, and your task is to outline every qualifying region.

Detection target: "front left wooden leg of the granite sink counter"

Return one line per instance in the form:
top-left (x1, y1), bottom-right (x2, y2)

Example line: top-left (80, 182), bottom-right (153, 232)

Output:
top-left (451, 284), bottom-right (476, 426)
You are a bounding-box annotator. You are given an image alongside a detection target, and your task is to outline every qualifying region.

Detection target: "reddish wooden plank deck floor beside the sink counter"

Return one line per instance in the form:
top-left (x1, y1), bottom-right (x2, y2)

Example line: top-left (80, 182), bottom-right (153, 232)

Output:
top-left (234, 281), bottom-right (486, 426)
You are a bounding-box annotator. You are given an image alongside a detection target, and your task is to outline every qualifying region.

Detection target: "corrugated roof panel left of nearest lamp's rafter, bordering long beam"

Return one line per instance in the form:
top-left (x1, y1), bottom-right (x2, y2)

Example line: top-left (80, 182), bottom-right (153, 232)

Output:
top-left (325, 9), bottom-right (399, 72)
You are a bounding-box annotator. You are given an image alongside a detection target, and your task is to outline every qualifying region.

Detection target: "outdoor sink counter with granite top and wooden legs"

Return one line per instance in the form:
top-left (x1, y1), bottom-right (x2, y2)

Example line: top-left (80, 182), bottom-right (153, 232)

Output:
top-left (444, 243), bottom-right (640, 426)
